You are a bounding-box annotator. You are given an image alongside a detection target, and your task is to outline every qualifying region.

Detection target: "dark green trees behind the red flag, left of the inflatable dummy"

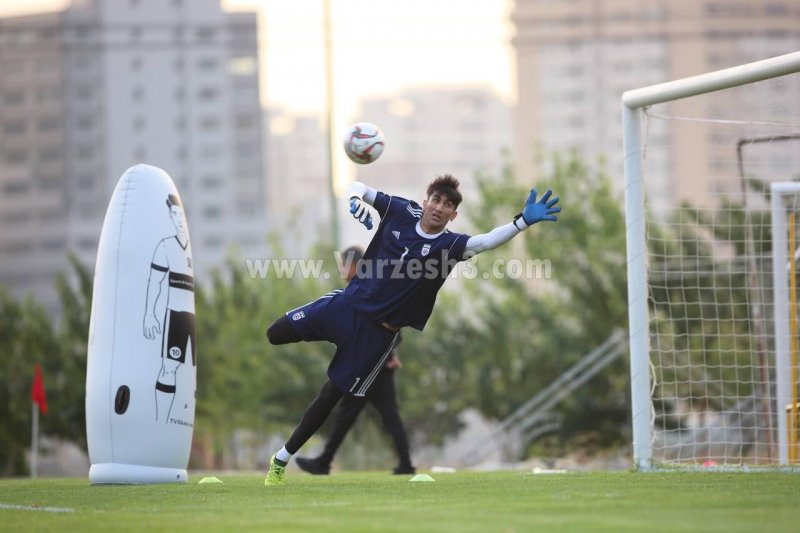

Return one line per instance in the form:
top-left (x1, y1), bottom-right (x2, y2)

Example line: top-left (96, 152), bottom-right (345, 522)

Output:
top-left (0, 255), bottom-right (92, 475)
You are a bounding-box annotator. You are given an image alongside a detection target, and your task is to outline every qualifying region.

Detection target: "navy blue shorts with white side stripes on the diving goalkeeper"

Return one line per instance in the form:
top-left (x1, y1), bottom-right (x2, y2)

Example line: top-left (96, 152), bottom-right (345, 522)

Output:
top-left (286, 290), bottom-right (398, 396)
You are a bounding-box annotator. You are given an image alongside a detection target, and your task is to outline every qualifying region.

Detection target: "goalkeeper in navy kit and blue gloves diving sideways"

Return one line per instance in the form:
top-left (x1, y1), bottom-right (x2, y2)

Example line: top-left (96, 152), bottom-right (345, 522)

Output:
top-left (264, 174), bottom-right (561, 485)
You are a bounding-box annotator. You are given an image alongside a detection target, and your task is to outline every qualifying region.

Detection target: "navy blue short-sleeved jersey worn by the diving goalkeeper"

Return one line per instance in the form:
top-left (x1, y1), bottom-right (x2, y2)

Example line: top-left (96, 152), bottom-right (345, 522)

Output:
top-left (342, 192), bottom-right (469, 330)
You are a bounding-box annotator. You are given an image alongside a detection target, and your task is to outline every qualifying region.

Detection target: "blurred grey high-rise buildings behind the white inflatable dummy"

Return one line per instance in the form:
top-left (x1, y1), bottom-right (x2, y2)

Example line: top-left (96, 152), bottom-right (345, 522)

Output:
top-left (0, 0), bottom-right (269, 308)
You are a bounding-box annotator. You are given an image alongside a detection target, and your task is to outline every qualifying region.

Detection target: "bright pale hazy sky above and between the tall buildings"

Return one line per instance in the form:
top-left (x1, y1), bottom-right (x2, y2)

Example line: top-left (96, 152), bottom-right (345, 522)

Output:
top-left (0, 0), bottom-right (514, 115)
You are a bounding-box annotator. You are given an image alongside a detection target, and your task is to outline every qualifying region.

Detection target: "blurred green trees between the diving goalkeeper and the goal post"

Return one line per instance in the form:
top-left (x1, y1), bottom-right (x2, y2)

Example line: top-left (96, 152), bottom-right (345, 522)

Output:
top-left (412, 155), bottom-right (629, 445)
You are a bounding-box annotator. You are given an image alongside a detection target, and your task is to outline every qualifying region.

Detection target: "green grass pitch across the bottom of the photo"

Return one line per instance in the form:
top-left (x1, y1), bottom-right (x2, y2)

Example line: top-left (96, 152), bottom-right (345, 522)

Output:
top-left (0, 472), bottom-right (800, 533)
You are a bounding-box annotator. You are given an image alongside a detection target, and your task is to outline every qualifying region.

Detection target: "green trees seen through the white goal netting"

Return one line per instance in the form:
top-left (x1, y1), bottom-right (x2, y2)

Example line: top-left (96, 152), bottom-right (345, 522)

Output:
top-left (649, 189), bottom-right (773, 434)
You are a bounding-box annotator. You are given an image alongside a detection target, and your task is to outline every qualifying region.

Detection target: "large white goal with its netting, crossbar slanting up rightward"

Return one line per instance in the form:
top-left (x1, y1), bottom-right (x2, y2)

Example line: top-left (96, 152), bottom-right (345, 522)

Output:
top-left (622, 52), bottom-right (800, 470)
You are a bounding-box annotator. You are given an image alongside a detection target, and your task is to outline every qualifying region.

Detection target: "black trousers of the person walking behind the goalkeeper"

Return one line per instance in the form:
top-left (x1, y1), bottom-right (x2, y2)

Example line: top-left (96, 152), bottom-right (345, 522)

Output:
top-left (319, 367), bottom-right (411, 467)
